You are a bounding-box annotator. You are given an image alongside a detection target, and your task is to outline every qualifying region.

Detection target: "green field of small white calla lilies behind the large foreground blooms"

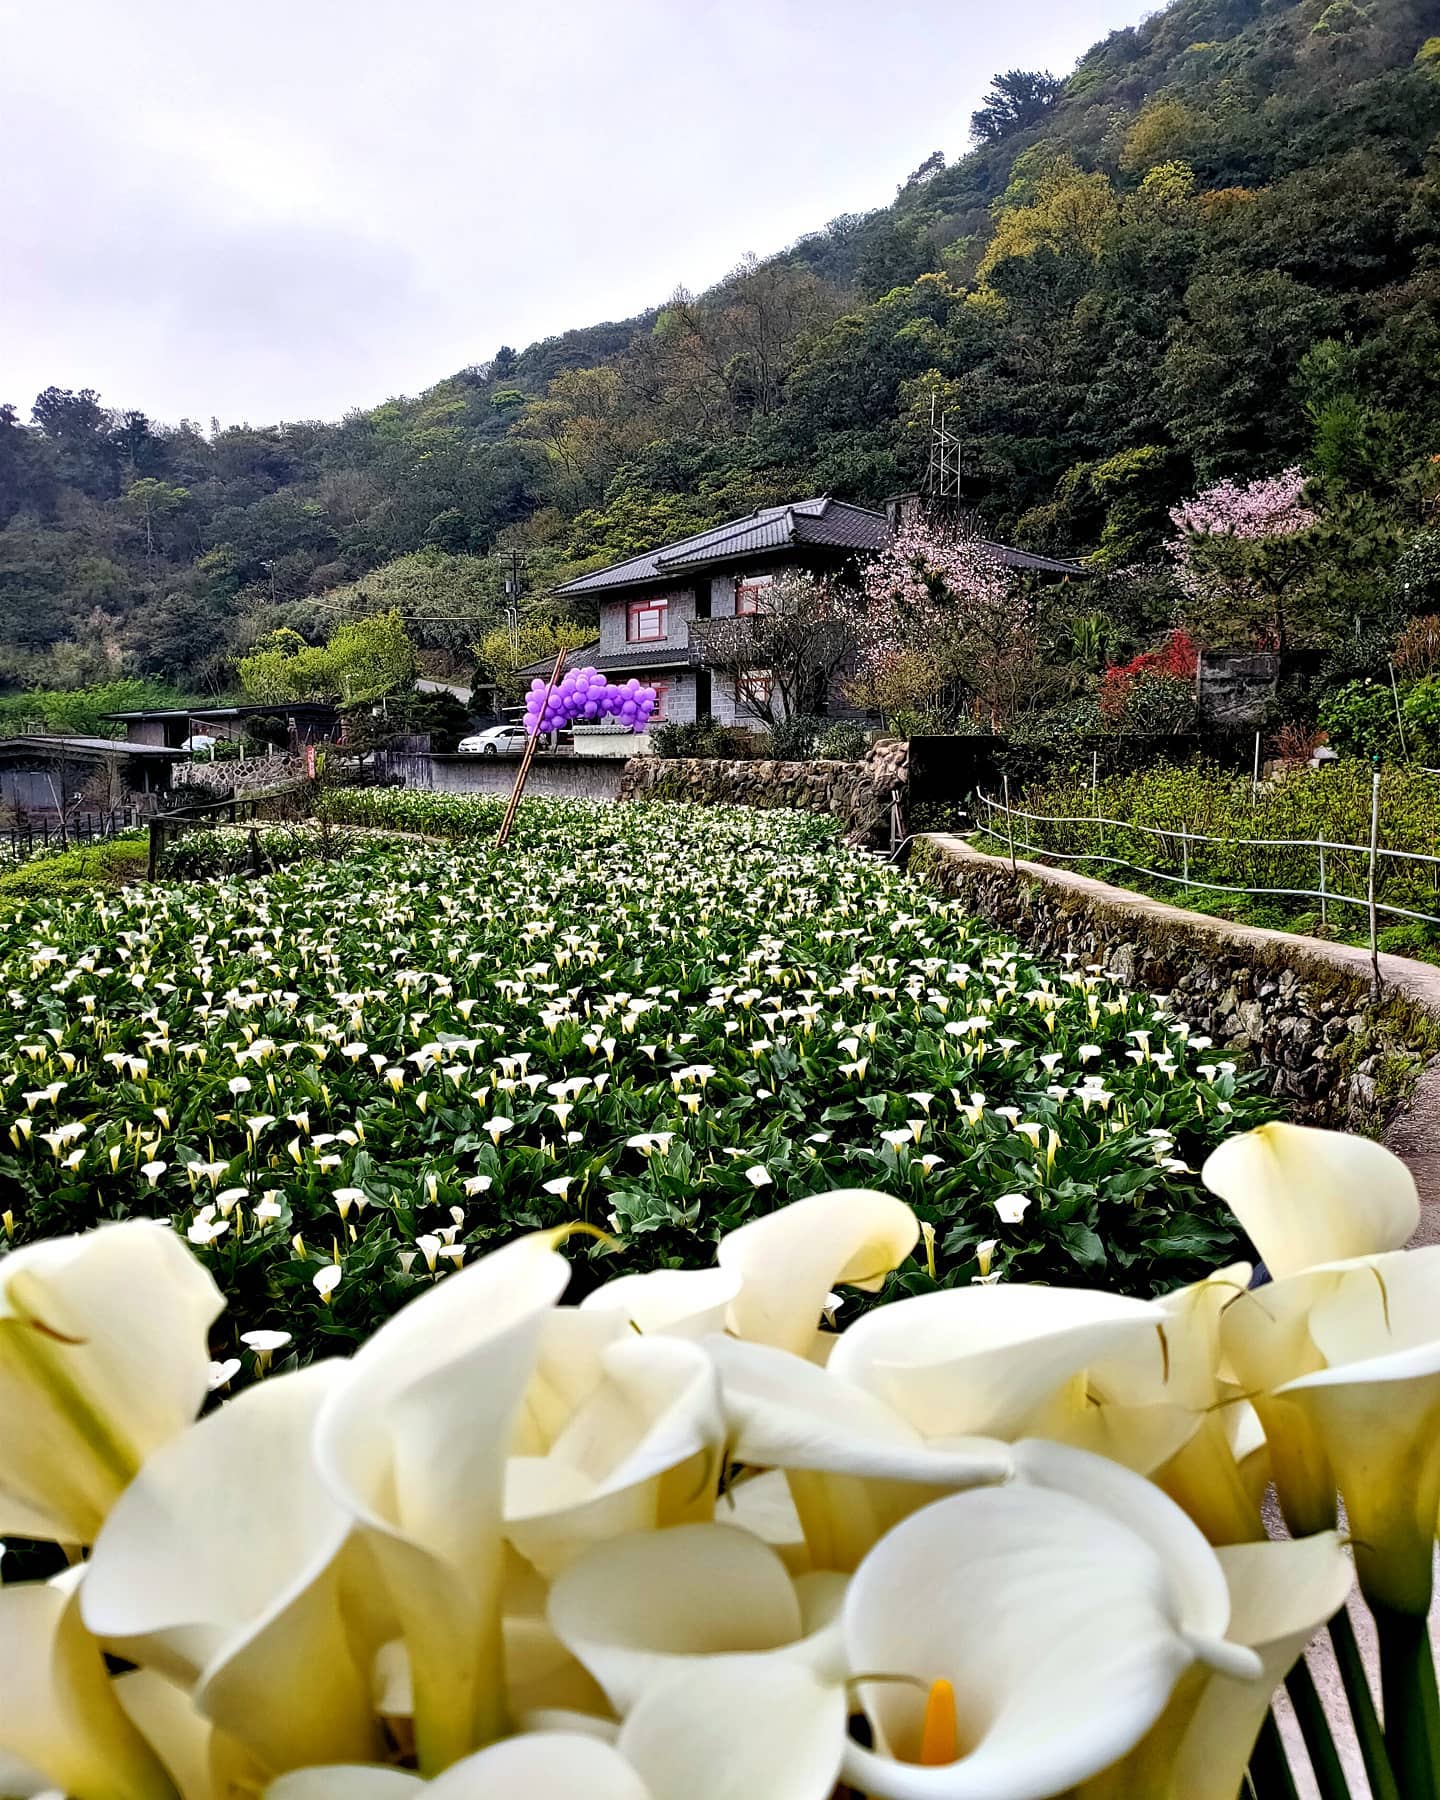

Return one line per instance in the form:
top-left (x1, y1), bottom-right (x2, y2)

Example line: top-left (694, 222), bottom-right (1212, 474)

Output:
top-left (0, 794), bottom-right (1269, 1379)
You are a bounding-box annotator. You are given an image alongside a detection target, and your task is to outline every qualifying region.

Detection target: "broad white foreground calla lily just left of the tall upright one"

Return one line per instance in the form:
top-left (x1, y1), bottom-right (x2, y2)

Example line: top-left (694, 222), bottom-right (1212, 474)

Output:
top-left (81, 1363), bottom-right (380, 1778)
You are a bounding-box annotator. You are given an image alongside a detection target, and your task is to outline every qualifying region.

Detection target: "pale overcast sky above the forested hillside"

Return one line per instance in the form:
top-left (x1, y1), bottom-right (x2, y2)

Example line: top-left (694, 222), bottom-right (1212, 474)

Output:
top-left (0, 0), bottom-right (1148, 425)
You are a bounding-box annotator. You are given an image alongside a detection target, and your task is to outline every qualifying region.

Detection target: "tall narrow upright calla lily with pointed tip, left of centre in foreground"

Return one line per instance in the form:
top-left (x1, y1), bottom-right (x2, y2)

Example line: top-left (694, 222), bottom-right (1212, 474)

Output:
top-left (315, 1235), bottom-right (569, 1775)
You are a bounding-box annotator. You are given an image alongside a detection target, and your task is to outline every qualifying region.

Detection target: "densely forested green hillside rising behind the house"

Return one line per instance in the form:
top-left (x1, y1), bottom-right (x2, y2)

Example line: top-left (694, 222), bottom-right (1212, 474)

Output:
top-left (0, 0), bottom-right (1440, 691)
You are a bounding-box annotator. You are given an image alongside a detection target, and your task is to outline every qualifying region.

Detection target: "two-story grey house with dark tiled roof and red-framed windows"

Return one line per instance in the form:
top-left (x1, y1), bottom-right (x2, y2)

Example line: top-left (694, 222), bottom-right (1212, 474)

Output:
top-left (524, 495), bottom-right (1084, 725)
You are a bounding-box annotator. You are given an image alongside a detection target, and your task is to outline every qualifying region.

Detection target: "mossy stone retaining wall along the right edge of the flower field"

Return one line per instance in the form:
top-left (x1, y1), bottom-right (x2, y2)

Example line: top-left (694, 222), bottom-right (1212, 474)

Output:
top-left (909, 833), bottom-right (1440, 1132)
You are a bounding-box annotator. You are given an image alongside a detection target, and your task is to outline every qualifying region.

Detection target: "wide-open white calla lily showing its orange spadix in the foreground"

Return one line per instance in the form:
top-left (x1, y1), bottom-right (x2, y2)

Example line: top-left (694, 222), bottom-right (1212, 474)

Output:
top-left (844, 1476), bottom-right (1253, 1800)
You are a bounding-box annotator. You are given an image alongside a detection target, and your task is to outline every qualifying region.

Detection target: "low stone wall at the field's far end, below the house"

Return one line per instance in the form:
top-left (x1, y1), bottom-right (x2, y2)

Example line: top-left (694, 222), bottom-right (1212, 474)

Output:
top-left (619, 740), bottom-right (909, 848)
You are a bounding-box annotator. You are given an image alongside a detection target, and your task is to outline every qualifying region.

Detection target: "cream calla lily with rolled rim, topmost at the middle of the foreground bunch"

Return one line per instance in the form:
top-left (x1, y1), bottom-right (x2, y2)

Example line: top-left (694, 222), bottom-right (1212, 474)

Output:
top-left (716, 1188), bottom-right (920, 1355)
